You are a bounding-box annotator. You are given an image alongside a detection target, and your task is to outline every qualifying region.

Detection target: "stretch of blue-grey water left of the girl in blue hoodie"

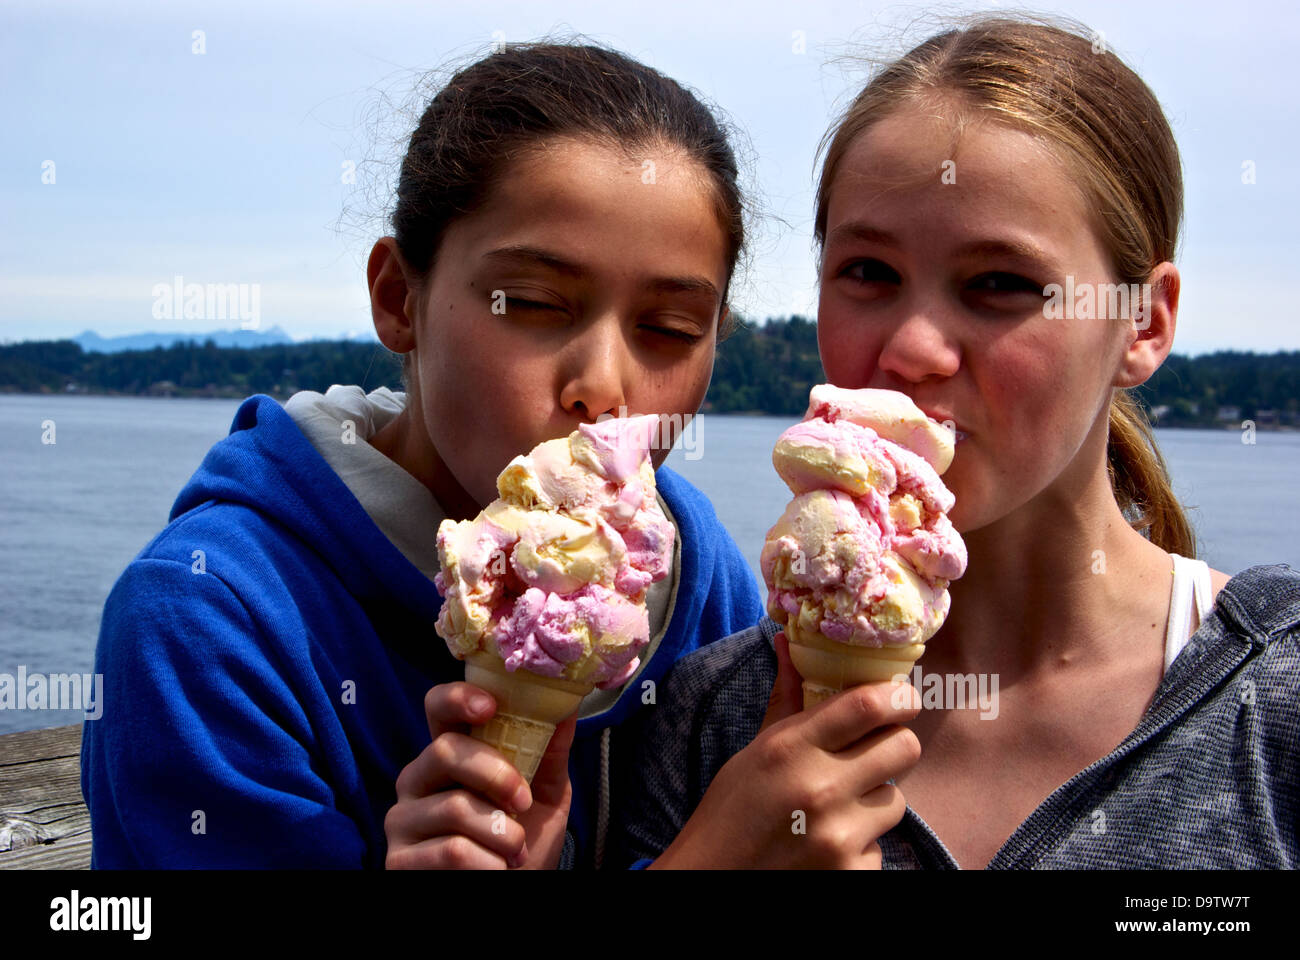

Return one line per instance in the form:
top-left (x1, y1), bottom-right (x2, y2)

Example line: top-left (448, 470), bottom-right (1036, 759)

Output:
top-left (0, 395), bottom-right (239, 734)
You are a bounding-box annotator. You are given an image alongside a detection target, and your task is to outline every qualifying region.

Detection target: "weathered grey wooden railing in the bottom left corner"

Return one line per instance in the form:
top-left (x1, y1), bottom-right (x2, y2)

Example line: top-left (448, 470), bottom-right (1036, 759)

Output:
top-left (0, 723), bottom-right (90, 870)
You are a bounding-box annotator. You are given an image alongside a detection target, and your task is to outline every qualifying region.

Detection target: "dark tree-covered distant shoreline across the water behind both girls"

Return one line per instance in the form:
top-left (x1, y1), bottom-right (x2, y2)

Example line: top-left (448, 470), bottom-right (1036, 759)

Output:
top-left (0, 325), bottom-right (1300, 421)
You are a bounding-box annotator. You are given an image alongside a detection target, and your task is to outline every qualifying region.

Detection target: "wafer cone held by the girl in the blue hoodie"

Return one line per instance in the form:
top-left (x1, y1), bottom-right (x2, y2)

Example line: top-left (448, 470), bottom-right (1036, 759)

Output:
top-left (465, 652), bottom-right (593, 783)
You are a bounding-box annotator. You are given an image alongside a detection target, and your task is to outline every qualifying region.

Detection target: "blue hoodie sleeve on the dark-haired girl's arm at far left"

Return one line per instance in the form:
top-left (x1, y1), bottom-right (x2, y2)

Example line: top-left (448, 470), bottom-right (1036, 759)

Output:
top-left (82, 559), bottom-right (367, 869)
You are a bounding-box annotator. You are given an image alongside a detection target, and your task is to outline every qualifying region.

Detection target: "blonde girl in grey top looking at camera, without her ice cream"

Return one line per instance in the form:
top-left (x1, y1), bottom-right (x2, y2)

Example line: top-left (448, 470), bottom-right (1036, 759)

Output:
top-left (618, 17), bottom-right (1300, 869)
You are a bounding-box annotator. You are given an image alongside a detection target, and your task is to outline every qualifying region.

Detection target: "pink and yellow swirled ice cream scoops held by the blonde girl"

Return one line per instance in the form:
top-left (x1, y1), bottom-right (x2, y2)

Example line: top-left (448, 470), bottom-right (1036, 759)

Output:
top-left (761, 385), bottom-right (966, 656)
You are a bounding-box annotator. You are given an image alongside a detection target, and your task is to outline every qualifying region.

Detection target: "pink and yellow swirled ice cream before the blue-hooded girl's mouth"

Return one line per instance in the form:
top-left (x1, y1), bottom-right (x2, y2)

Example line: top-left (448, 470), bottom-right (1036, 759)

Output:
top-left (436, 416), bottom-right (673, 688)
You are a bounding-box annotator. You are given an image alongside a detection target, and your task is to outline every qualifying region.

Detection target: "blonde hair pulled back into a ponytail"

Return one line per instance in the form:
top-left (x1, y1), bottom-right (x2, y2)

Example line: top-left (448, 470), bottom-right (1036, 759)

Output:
top-left (814, 14), bottom-right (1196, 557)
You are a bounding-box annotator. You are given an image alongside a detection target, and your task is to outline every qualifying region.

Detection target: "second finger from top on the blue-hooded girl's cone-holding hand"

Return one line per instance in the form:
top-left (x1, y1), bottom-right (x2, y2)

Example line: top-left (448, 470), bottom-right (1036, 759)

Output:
top-left (397, 732), bottom-right (533, 813)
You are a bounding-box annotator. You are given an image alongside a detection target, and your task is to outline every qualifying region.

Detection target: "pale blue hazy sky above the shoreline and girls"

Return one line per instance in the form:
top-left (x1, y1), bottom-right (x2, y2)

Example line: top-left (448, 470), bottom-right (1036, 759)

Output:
top-left (0, 0), bottom-right (1300, 354)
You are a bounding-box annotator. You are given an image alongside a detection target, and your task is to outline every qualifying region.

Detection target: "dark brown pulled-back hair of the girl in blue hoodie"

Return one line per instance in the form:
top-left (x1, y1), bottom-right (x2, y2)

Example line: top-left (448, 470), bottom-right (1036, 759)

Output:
top-left (391, 43), bottom-right (745, 371)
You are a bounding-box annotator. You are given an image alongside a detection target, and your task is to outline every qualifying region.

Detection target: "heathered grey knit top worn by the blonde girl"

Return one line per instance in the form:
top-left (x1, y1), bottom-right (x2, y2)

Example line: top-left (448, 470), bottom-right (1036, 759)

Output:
top-left (608, 565), bottom-right (1300, 869)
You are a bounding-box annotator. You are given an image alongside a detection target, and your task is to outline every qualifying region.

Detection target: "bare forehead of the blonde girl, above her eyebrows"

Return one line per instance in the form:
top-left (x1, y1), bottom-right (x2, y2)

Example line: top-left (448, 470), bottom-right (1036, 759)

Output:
top-left (827, 104), bottom-right (1095, 247)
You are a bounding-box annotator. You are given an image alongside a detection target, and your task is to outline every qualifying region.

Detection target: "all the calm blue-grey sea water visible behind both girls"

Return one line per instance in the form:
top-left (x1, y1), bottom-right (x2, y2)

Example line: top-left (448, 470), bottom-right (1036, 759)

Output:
top-left (0, 395), bottom-right (1300, 734)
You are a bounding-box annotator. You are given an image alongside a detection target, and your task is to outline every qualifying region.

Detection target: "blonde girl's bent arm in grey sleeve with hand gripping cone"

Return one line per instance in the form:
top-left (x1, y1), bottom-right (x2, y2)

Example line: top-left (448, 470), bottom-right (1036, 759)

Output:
top-left (619, 631), bottom-right (920, 868)
